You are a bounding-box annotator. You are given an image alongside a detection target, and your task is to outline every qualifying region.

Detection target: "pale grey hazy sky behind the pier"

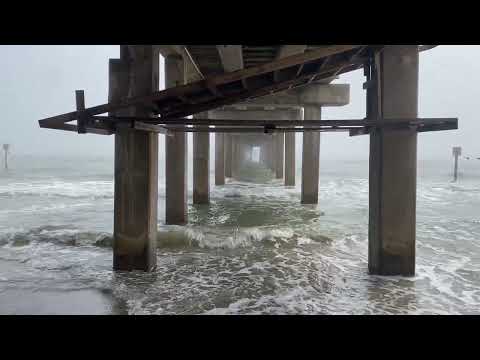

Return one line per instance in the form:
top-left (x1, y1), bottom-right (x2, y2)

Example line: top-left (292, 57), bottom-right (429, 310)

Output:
top-left (0, 45), bottom-right (480, 160)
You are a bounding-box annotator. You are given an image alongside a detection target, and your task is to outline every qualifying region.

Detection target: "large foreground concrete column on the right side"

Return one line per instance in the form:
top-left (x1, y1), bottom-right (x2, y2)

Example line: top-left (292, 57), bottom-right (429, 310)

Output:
top-left (367, 45), bottom-right (418, 276)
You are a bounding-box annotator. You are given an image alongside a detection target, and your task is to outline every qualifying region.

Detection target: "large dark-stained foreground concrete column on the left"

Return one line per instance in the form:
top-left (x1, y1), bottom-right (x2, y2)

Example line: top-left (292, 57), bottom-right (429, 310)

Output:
top-left (109, 45), bottom-right (159, 271)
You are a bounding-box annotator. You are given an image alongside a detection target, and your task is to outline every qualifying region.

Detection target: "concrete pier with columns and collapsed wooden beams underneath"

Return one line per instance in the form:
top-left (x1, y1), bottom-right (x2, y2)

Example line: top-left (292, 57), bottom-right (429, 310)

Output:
top-left (39, 45), bottom-right (458, 276)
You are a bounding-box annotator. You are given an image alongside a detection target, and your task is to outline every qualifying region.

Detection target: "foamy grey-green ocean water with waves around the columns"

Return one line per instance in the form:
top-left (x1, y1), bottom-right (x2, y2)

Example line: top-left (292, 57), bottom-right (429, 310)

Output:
top-left (0, 157), bottom-right (480, 314)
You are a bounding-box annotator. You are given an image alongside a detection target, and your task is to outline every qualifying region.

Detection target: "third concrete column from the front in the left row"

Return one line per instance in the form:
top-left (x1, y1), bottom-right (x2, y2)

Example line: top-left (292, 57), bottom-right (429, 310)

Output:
top-left (193, 113), bottom-right (210, 204)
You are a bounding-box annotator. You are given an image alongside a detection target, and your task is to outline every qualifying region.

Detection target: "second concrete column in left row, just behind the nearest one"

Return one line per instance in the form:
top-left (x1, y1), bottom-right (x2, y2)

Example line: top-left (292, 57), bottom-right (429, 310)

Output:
top-left (165, 55), bottom-right (188, 225)
